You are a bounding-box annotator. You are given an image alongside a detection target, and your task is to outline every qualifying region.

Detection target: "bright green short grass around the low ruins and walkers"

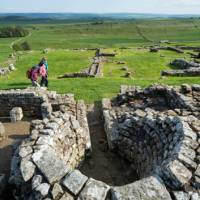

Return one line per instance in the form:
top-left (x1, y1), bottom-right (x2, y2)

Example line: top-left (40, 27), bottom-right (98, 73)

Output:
top-left (0, 49), bottom-right (200, 103)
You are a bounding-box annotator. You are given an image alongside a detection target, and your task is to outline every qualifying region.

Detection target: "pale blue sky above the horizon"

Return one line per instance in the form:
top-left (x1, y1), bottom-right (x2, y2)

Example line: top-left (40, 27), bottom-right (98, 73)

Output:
top-left (0, 0), bottom-right (200, 14)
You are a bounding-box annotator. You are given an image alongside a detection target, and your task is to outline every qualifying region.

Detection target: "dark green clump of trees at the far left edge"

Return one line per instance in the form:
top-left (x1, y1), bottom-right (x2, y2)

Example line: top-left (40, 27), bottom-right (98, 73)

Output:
top-left (0, 26), bottom-right (29, 38)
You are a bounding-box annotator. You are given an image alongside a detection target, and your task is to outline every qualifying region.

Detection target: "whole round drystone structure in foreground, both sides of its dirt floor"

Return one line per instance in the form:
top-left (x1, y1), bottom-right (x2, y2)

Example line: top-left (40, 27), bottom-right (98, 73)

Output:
top-left (4, 85), bottom-right (200, 200)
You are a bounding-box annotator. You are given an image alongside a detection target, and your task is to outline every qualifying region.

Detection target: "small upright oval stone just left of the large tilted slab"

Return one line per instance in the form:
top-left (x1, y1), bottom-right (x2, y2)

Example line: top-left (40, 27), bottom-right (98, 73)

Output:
top-left (20, 160), bottom-right (35, 182)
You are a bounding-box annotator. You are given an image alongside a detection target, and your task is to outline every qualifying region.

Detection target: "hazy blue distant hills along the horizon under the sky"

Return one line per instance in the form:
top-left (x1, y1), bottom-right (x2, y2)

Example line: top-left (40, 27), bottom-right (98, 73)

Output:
top-left (0, 13), bottom-right (200, 23)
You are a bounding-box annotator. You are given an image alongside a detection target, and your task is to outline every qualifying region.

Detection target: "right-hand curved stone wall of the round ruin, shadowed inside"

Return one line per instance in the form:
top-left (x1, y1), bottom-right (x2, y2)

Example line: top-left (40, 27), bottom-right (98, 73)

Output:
top-left (102, 85), bottom-right (200, 200)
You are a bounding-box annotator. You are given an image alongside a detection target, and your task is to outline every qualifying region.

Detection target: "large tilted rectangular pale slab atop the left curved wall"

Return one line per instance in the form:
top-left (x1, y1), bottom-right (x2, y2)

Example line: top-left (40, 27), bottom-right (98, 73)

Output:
top-left (32, 148), bottom-right (69, 184)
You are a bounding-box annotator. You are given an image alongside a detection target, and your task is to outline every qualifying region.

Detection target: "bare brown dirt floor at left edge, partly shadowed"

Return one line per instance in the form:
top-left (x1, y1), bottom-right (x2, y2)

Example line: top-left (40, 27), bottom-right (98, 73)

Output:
top-left (0, 121), bottom-right (30, 176)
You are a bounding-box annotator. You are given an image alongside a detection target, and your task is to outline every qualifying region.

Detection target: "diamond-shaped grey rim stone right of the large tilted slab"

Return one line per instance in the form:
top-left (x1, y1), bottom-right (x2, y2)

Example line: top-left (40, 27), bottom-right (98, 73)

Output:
top-left (63, 170), bottom-right (88, 195)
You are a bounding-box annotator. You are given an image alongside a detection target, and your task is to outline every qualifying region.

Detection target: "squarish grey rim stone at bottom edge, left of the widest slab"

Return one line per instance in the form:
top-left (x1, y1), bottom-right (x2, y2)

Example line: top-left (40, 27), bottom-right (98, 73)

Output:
top-left (79, 178), bottom-right (110, 200)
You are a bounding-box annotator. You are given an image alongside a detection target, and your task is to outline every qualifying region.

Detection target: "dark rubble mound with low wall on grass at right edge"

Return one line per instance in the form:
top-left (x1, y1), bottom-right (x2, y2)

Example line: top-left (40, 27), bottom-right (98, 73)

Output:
top-left (161, 59), bottom-right (200, 76)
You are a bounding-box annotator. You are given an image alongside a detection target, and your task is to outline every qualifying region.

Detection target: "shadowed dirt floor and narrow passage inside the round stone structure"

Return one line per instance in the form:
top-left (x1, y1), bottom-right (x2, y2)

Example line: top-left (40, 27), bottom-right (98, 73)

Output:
top-left (80, 105), bottom-right (137, 186)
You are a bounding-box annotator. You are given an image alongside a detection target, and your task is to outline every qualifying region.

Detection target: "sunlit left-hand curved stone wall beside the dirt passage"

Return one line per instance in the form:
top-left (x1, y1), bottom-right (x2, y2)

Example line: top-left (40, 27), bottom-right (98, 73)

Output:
top-left (9, 90), bottom-right (91, 200)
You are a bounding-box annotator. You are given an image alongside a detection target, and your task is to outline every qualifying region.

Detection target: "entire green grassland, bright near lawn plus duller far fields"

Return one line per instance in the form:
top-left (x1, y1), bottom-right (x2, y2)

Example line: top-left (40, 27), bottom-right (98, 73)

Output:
top-left (0, 19), bottom-right (200, 102)
